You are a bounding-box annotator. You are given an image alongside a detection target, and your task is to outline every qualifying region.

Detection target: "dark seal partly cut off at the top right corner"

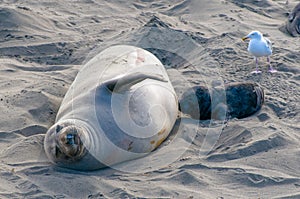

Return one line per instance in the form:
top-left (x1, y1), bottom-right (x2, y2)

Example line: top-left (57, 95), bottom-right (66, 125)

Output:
top-left (281, 3), bottom-right (300, 37)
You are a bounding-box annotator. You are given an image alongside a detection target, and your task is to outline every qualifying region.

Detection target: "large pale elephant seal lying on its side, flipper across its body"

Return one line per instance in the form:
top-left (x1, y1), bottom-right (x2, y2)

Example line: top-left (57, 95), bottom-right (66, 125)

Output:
top-left (44, 45), bottom-right (178, 170)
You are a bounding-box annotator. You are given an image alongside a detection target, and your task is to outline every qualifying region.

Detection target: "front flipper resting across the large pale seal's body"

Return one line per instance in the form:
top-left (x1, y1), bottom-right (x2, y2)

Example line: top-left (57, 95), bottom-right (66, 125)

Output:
top-left (103, 72), bottom-right (168, 92)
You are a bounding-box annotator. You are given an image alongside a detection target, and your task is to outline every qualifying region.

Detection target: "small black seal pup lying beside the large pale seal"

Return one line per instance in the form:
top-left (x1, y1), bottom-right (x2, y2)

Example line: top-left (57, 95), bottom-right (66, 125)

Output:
top-left (179, 82), bottom-right (264, 120)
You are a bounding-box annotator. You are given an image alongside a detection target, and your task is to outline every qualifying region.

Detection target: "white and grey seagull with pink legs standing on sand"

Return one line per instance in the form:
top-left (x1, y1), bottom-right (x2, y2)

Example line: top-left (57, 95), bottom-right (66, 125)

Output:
top-left (242, 31), bottom-right (277, 74)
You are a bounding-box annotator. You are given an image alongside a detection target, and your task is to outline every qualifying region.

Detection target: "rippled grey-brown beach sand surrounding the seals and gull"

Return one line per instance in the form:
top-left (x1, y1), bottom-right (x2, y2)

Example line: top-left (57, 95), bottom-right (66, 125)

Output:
top-left (0, 0), bottom-right (300, 199)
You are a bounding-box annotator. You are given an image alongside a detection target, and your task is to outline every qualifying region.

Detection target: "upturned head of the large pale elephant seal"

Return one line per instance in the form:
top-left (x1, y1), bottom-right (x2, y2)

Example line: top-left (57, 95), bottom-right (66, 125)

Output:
top-left (44, 123), bottom-right (88, 167)
